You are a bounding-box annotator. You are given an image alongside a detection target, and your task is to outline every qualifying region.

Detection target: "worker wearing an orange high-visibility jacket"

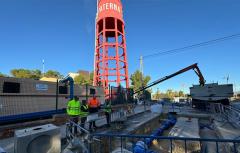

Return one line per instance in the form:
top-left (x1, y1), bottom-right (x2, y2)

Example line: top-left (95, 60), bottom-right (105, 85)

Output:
top-left (88, 95), bottom-right (100, 131)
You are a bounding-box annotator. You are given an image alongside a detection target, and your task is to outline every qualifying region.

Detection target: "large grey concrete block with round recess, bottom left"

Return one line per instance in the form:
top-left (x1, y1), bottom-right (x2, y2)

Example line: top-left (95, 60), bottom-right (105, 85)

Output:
top-left (14, 124), bottom-right (61, 153)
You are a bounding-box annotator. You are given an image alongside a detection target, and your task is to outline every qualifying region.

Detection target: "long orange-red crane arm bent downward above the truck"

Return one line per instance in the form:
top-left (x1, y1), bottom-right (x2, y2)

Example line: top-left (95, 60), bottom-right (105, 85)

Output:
top-left (134, 63), bottom-right (205, 94)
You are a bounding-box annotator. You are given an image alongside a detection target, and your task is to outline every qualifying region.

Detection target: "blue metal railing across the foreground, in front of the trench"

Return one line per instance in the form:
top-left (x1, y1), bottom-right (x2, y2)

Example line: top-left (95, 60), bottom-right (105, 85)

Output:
top-left (89, 134), bottom-right (240, 153)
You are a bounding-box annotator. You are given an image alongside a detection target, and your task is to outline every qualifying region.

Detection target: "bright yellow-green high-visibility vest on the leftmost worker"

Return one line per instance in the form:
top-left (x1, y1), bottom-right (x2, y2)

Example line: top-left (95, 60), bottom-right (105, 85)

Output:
top-left (67, 100), bottom-right (80, 116)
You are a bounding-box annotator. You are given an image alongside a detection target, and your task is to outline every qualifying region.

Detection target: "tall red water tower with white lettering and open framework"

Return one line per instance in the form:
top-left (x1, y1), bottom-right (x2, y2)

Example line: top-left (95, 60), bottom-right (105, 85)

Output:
top-left (93, 0), bottom-right (129, 95)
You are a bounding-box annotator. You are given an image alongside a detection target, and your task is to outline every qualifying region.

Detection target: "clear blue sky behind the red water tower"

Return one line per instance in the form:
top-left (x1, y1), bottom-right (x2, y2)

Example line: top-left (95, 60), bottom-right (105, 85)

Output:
top-left (0, 0), bottom-right (240, 91)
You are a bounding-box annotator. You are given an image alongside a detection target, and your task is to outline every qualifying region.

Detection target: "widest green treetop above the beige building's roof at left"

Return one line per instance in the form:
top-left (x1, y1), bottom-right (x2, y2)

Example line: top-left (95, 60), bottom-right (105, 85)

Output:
top-left (11, 69), bottom-right (42, 79)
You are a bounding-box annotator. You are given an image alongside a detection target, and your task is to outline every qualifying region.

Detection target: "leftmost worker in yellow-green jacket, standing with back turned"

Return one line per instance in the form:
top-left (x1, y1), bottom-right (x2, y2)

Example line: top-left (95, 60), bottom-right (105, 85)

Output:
top-left (67, 96), bottom-right (80, 134)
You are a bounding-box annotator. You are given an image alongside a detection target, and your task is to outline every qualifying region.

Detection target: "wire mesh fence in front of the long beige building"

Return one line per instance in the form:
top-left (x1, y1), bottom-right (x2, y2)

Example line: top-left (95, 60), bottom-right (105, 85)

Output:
top-left (0, 77), bottom-right (105, 124)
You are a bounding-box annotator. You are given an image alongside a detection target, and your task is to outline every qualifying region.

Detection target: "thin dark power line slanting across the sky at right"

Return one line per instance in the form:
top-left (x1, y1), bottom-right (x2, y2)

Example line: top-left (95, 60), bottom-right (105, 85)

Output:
top-left (143, 33), bottom-right (240, 59)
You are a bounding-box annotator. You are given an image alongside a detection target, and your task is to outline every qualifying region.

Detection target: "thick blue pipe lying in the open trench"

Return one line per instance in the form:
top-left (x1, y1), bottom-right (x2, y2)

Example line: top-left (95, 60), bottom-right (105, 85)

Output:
top-left (133, 114), bottom-right (177, 153)
